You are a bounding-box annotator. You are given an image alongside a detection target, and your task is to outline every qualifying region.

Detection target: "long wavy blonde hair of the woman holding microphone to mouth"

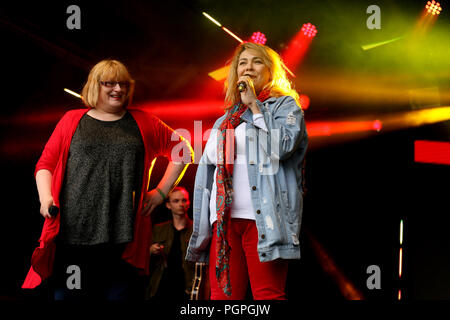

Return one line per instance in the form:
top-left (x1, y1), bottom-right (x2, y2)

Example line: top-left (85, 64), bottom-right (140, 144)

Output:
top-left (224, 42), bottom-right (300, 109)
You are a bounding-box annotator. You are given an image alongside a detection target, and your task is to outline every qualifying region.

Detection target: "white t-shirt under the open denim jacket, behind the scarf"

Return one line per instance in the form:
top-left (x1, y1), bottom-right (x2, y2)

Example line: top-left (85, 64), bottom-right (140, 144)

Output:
top-left (205, 114), bottom-right (267, 225)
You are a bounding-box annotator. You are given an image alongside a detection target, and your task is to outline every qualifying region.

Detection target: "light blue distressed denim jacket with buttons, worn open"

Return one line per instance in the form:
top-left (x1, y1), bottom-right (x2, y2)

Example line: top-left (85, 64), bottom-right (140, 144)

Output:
top-left (186, 96), bottom-right (308, 262)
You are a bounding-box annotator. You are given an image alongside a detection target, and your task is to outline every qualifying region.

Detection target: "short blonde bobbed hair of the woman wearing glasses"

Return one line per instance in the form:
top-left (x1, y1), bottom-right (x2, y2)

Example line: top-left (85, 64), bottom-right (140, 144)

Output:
top-left (81, 60), bottom-right (134, 108)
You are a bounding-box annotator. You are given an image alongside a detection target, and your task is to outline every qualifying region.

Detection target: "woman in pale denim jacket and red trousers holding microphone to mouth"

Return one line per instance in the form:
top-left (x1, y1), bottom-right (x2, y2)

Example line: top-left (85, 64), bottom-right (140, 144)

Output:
top-left (186, 43), bottom-right (307, 300)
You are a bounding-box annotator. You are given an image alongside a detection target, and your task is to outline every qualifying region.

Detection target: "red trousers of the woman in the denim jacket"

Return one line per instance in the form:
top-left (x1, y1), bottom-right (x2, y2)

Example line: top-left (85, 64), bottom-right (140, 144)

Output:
top-left (209, 219), bottom-right (288, 300)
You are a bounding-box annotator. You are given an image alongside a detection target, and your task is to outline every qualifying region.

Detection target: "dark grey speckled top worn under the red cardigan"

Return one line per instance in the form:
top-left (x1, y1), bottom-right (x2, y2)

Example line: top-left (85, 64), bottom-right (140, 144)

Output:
top-left (60, 112), bottom-right (145, 245)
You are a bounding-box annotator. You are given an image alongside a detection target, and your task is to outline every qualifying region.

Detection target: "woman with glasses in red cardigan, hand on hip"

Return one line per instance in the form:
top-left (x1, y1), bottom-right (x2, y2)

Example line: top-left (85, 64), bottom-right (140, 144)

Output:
top-left (22, 60), bottom-right (193, 300)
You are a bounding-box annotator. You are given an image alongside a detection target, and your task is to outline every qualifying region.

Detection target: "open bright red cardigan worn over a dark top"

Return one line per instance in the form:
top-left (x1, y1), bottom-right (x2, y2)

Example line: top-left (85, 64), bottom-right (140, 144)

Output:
top-left (22, 109), bottom-right (194, 289)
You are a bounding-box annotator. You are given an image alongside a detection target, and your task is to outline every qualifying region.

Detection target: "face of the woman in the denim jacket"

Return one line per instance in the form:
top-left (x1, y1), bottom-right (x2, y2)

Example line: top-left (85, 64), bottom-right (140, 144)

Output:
top-left (237, 49), bottom-right (270, 94)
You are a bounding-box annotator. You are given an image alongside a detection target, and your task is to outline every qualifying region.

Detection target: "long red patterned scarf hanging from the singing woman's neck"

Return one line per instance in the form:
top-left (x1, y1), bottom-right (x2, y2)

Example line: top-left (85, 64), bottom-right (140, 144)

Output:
top-left (216, 90), bottom-right (270, 296)
